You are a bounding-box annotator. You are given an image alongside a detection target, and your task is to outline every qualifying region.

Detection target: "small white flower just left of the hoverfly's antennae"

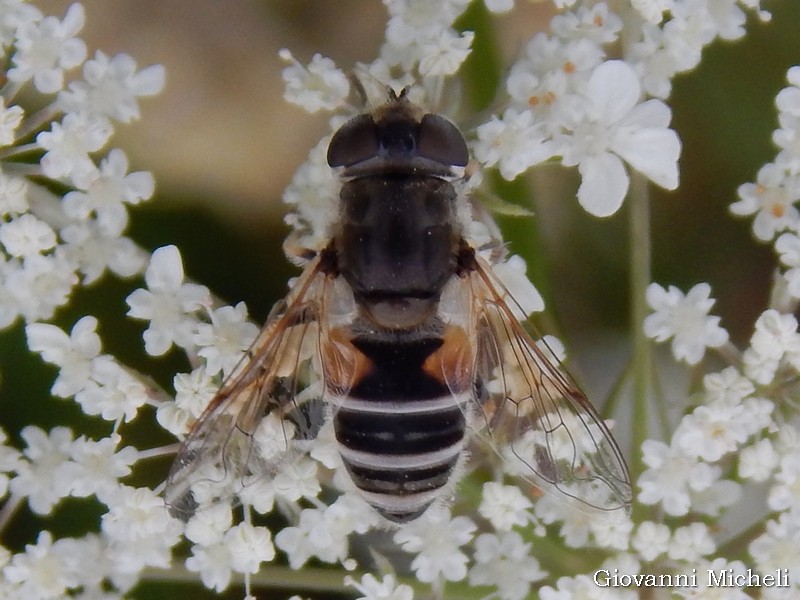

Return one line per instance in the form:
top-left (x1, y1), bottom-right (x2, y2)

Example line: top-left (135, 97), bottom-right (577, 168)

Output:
top-left (280, 48), bottom-right (350, 113)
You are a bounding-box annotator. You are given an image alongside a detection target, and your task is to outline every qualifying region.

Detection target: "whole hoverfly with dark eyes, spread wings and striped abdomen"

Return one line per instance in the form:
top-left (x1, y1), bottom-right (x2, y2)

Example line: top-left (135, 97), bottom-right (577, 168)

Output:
top-left (165, 90), bottom-right (631, 523)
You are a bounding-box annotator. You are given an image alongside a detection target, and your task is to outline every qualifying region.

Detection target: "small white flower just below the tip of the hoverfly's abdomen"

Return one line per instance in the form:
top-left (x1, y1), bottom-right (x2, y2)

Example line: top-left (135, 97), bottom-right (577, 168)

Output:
top-left (394, 505), bottom-right (476, 582)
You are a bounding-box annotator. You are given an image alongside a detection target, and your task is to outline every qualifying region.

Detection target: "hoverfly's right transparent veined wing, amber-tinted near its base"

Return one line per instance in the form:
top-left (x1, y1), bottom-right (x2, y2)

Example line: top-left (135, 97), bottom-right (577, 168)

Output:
top-left (465, 258), bottom-right (632, 511)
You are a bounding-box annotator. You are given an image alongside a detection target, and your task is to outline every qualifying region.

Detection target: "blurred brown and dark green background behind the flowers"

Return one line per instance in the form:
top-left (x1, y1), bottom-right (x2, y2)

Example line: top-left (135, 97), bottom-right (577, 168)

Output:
top-left (0, 0), bottom-right (800, 598)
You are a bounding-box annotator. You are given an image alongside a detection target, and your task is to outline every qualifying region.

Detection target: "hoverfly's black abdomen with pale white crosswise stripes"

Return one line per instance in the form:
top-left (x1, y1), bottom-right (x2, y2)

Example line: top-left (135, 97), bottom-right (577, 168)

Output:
top-left (333, 334), bottom-right (467, 522)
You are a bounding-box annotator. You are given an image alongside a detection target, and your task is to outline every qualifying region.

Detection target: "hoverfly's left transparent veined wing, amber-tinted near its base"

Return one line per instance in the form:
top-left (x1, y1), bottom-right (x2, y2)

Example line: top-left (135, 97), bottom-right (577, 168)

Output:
top-left (164, 260), bottom-right (344, 521)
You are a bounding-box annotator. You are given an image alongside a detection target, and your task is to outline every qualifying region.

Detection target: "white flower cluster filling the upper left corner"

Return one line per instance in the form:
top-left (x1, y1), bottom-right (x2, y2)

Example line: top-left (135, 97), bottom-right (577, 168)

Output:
top-left (0, 2), bottom-right (164, 327)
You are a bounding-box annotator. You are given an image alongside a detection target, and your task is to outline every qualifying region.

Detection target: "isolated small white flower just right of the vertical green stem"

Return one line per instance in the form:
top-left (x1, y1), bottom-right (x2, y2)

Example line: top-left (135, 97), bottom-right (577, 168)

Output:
top-left (644, 283), bottom-right (728, 365)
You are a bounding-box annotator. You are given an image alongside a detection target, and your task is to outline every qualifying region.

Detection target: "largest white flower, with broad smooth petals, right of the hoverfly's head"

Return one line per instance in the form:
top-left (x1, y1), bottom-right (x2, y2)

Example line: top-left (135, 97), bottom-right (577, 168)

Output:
top-left (558, 60), bottom-right (681, 217)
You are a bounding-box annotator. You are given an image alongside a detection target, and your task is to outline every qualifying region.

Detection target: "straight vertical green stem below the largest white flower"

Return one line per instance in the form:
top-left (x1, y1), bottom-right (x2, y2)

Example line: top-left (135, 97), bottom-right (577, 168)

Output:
top-left (628, 172), bottom-right (653, 502)
